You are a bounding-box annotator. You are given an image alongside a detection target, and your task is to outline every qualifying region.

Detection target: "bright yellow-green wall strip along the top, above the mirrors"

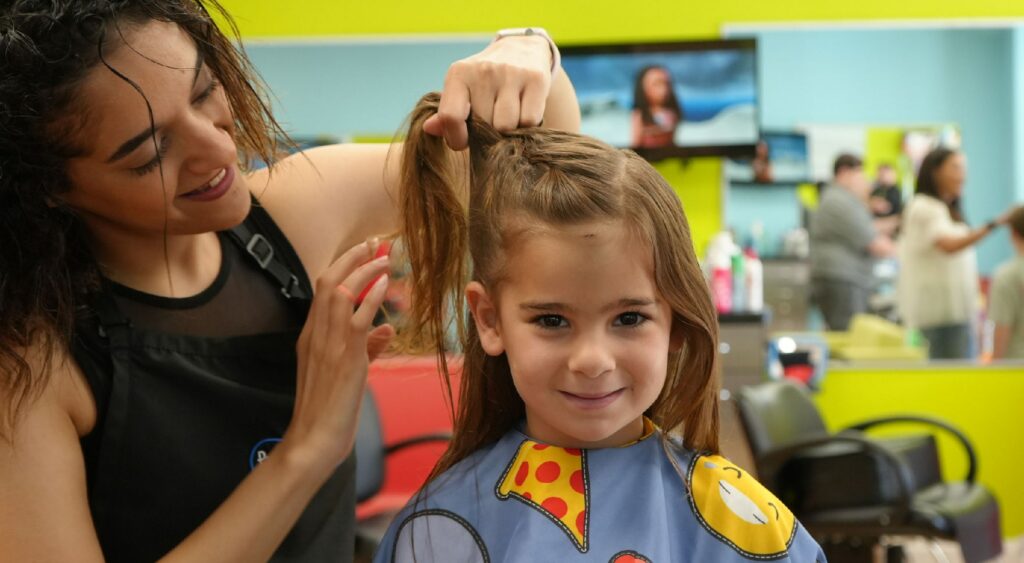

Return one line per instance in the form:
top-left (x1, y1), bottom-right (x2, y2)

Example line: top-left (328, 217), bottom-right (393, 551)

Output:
top-left (221, 0), bottom-right (1024, 43)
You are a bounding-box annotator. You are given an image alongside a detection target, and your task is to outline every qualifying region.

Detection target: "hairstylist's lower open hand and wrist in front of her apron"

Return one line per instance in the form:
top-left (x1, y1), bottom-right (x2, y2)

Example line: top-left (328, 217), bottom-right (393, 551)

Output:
top-left (285, 243), bottom-right (393, 470)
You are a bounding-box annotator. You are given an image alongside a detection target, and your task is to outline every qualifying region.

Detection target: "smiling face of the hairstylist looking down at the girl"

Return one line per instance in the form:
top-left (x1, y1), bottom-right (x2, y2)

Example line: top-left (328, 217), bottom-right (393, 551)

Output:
top-left (63, 23), bottom-right (249, 242)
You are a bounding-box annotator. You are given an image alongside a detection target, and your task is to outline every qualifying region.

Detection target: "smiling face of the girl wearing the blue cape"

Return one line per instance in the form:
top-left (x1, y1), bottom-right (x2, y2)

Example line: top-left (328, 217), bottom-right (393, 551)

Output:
top-left (467, 221), bottom-right (673, 447)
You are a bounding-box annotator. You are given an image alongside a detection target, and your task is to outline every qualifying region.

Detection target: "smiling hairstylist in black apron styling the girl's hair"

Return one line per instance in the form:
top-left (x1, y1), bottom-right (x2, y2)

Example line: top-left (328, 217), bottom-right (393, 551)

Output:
top-left (0, 0), bottom-right (579, 562)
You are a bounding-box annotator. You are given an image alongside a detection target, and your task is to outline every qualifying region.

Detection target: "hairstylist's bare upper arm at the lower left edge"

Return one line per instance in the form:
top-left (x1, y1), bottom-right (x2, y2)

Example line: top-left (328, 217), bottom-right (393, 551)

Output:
top-left (0, 346), bottom-right (102, 562)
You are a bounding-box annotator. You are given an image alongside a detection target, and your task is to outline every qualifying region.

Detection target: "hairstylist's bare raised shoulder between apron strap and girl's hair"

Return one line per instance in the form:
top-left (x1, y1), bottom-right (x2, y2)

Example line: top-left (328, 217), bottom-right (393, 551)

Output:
top-left (249, 143), bottom-right (401, 277)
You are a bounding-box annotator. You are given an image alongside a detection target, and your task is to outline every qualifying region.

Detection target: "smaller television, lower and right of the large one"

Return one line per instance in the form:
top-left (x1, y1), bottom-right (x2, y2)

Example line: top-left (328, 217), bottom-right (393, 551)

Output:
top-left (725, 131), bottom-right (811, 184)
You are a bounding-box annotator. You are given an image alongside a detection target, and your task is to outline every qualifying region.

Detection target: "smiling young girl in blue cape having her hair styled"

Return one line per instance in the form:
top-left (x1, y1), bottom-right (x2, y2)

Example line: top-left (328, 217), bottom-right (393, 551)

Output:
top-left (376, 96), bottom-right (824, 562)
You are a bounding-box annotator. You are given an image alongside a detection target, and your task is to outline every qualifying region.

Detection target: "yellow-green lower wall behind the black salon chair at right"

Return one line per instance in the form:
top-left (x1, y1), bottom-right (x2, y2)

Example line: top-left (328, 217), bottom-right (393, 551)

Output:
top-left (816, 366), bottom-right (1024, 536)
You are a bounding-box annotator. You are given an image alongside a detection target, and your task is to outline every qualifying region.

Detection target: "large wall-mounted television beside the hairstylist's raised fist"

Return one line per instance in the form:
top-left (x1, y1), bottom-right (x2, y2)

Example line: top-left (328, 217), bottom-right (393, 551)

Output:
top-left (562, 39), bottom-right (759, 160)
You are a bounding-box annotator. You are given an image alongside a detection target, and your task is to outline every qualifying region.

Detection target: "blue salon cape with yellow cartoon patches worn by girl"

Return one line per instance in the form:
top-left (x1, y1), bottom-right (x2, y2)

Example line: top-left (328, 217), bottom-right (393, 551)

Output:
top-left (374, 421), bottom-right (825, 563)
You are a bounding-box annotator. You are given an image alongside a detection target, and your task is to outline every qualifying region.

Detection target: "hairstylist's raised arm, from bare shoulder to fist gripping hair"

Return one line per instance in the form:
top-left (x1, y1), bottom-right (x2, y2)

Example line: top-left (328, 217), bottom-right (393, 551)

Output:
top-left (250, 31), bottom-right (580, 276)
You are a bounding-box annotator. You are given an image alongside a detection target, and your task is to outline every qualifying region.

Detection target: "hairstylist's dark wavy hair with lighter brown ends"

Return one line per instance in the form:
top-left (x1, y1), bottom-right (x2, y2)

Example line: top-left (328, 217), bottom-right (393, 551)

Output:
top-left (0, 0), bottom-right (287, 435)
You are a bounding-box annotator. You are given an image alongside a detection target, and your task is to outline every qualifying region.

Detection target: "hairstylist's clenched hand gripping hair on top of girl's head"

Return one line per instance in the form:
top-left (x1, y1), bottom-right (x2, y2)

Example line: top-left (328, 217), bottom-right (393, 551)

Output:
top-left (423, 36), bottom-right (552, 150)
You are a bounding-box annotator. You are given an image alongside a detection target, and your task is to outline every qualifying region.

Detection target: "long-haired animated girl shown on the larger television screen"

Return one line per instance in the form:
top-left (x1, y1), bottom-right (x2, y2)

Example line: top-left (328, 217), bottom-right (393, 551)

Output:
top-left (633, 66), bottom-right (683, 148)
